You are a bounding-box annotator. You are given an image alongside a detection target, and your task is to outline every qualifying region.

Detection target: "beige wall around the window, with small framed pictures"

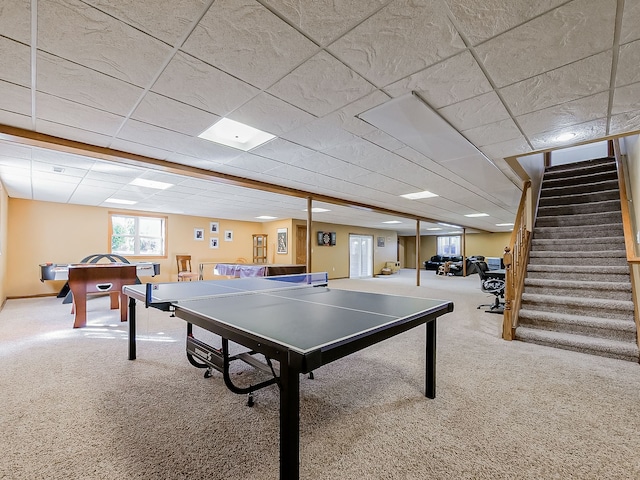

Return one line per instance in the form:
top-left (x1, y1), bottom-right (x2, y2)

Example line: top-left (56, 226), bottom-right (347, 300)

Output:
top-left (5, 198), bottom-right (266, 297)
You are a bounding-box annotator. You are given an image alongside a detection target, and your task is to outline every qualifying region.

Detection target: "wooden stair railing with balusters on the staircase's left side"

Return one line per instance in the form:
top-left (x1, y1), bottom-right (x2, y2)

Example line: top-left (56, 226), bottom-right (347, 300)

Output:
top-left (502, 181), bottom-right (532, 340)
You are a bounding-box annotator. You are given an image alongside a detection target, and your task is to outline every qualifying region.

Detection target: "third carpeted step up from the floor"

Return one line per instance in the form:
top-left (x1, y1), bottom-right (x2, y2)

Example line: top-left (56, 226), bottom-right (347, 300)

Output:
top-left (521, 293), bottom-right (634, 320)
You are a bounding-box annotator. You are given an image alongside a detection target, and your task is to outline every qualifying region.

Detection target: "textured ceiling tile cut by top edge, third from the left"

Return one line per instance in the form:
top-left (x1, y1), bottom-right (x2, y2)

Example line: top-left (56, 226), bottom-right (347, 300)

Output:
top-left (85, 0), bottom-right (210, 45)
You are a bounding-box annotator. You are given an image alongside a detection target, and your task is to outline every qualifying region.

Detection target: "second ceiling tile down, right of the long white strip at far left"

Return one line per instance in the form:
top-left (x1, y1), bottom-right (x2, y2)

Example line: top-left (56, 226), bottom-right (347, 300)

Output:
top-left (37, 52), bottom-right (142, 115)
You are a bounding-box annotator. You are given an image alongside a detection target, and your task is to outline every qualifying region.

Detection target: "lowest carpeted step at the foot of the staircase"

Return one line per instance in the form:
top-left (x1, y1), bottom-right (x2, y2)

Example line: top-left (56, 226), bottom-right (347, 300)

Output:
top-left (515, 327), bottom-right (640, 362)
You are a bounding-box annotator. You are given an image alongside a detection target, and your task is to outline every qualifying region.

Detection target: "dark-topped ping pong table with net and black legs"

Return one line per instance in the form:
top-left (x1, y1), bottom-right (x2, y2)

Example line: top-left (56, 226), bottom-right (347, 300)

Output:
top-left (123, 272), bottom-right (453, 480)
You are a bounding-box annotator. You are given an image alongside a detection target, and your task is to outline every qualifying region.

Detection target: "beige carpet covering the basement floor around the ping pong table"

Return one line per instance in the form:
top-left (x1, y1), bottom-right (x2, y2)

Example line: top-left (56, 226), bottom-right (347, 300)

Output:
top-left (0, 270), bottom-right (640, 480)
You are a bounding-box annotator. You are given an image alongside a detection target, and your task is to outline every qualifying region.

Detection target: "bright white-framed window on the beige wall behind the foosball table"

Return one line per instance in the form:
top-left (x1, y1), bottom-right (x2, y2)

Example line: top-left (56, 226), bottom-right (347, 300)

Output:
top-left (109, 213), bottom-right (167, 257)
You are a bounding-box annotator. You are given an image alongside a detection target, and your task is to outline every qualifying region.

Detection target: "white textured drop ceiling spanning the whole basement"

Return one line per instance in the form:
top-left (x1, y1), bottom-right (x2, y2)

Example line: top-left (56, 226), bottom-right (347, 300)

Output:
top-left (0, 0), bottom-right (640, 234)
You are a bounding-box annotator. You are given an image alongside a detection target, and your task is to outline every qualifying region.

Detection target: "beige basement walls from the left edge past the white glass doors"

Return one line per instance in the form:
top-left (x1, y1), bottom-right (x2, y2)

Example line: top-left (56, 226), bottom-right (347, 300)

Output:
top-left (0, 198), bottom-right (397, 300)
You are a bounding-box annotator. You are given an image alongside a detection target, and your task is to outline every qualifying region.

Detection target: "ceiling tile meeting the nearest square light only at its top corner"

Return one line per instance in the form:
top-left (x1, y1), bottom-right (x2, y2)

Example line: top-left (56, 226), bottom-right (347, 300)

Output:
top-left (152, 52), bottom-right (260, 116)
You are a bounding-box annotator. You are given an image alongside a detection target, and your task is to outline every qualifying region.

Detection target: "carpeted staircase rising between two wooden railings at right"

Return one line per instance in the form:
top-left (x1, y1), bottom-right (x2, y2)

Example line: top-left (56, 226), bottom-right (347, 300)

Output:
top-left (515, 158), bottom-right (640, 362)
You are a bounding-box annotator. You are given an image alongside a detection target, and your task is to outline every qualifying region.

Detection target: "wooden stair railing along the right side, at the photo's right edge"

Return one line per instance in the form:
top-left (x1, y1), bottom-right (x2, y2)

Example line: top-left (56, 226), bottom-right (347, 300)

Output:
top-left (610, 138), bottom-right (640, 347)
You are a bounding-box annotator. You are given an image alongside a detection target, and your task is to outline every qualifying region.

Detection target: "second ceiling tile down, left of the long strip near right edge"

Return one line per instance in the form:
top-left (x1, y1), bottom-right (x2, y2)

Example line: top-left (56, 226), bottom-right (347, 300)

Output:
top-left (500, 51), bottom-right (612, 116)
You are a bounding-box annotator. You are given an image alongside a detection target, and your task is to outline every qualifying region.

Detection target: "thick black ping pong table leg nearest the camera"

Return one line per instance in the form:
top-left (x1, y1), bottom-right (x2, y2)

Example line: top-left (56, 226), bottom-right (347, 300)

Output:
top-left (280, 359), bottom-right (300, 480)
